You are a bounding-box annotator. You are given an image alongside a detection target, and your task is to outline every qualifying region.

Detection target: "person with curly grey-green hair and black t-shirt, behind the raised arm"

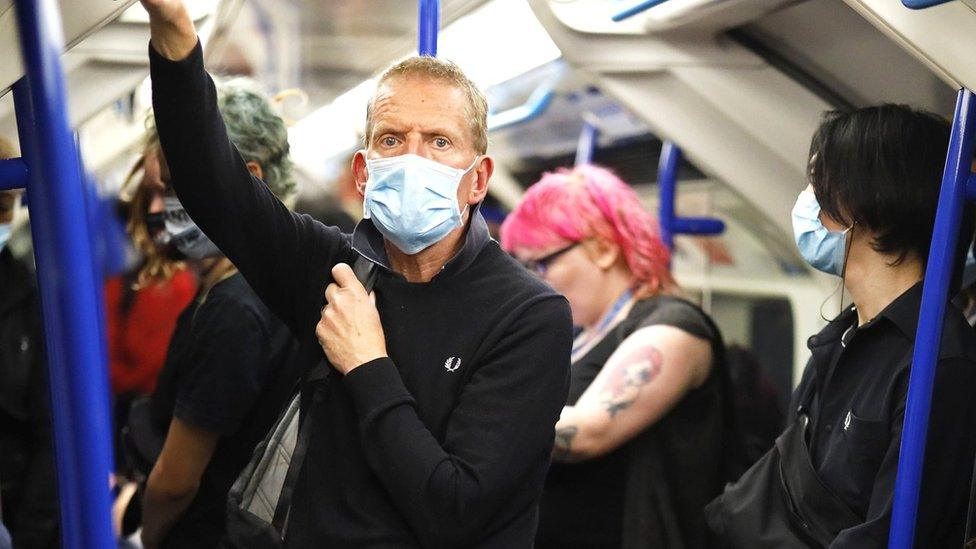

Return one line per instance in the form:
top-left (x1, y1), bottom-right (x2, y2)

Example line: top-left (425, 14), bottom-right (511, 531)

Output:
top-left (142, 82), bottom-right (300, 549)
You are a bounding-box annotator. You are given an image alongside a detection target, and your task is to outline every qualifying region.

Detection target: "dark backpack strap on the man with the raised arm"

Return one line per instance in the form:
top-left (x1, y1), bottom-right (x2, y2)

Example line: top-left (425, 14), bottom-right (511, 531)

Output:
top-left (271, 254), bottom-right (377, 537)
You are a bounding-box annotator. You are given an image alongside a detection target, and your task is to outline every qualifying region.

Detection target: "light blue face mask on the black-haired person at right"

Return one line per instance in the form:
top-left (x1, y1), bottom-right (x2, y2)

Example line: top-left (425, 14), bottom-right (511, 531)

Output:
top-left (793, 190), bottom-right (853, 276)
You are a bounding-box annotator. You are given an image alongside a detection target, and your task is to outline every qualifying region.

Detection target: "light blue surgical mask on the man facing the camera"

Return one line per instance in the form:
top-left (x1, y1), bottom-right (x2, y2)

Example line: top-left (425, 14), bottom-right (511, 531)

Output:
top-left (363, 154), bottom-right (478, 255)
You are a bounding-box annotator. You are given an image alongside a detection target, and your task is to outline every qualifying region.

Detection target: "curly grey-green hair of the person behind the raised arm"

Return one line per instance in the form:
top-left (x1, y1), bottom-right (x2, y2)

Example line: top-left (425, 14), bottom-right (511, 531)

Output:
top-left (217, 78), bottom-right (298, 200)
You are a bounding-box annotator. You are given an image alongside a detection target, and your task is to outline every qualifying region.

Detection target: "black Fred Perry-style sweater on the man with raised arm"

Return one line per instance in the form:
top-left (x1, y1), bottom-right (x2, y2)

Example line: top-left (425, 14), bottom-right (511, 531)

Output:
top-left (150, 45), bottom-right (572, 548)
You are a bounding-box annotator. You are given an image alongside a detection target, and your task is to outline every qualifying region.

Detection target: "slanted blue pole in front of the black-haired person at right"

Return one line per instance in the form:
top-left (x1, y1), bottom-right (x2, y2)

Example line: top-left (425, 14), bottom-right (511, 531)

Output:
top-left (888, 89), bottom-right (976, 549)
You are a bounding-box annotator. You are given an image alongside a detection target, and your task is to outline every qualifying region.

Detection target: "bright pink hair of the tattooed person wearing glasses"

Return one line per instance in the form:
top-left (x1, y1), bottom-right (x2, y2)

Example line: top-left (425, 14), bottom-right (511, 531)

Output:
top-left (501, 165), bottom-right (674, 293)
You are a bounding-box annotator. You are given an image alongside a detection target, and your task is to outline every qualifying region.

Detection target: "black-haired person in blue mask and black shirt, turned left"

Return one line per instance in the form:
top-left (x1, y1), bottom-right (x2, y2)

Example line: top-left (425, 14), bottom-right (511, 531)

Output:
top-left (706, 105), bottom-right (976, 548)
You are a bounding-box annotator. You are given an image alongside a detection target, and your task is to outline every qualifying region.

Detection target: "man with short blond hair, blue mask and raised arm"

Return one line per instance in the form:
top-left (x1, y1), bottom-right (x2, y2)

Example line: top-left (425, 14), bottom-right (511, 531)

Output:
top-left (143, 0), bottom-right (572, 548)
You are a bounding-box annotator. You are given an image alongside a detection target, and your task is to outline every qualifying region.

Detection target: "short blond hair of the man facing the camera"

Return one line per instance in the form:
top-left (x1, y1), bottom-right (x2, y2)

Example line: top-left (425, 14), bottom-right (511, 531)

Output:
top-left (363, 55), bottom-right (488, 154)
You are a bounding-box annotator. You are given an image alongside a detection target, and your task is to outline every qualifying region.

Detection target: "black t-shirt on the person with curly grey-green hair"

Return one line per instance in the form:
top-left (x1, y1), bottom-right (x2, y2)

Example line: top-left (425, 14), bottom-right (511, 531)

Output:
top-left (151, 274), bottom-right (300, 548)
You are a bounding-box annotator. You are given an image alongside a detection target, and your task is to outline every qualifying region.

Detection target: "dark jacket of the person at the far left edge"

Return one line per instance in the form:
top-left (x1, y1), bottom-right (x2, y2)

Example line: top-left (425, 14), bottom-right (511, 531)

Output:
top-left (0, 249), bottom-right (59, 548)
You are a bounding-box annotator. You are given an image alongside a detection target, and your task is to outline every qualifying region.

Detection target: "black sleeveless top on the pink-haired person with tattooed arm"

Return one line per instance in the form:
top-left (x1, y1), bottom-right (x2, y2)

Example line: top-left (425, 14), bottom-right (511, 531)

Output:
top-left (536, 296), bottom-right (731, 549)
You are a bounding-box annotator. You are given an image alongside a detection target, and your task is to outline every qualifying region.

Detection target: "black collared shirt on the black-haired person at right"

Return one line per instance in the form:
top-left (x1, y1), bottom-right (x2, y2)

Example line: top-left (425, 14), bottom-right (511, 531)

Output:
top-left (791, 282), bottom-right (976, 548)
